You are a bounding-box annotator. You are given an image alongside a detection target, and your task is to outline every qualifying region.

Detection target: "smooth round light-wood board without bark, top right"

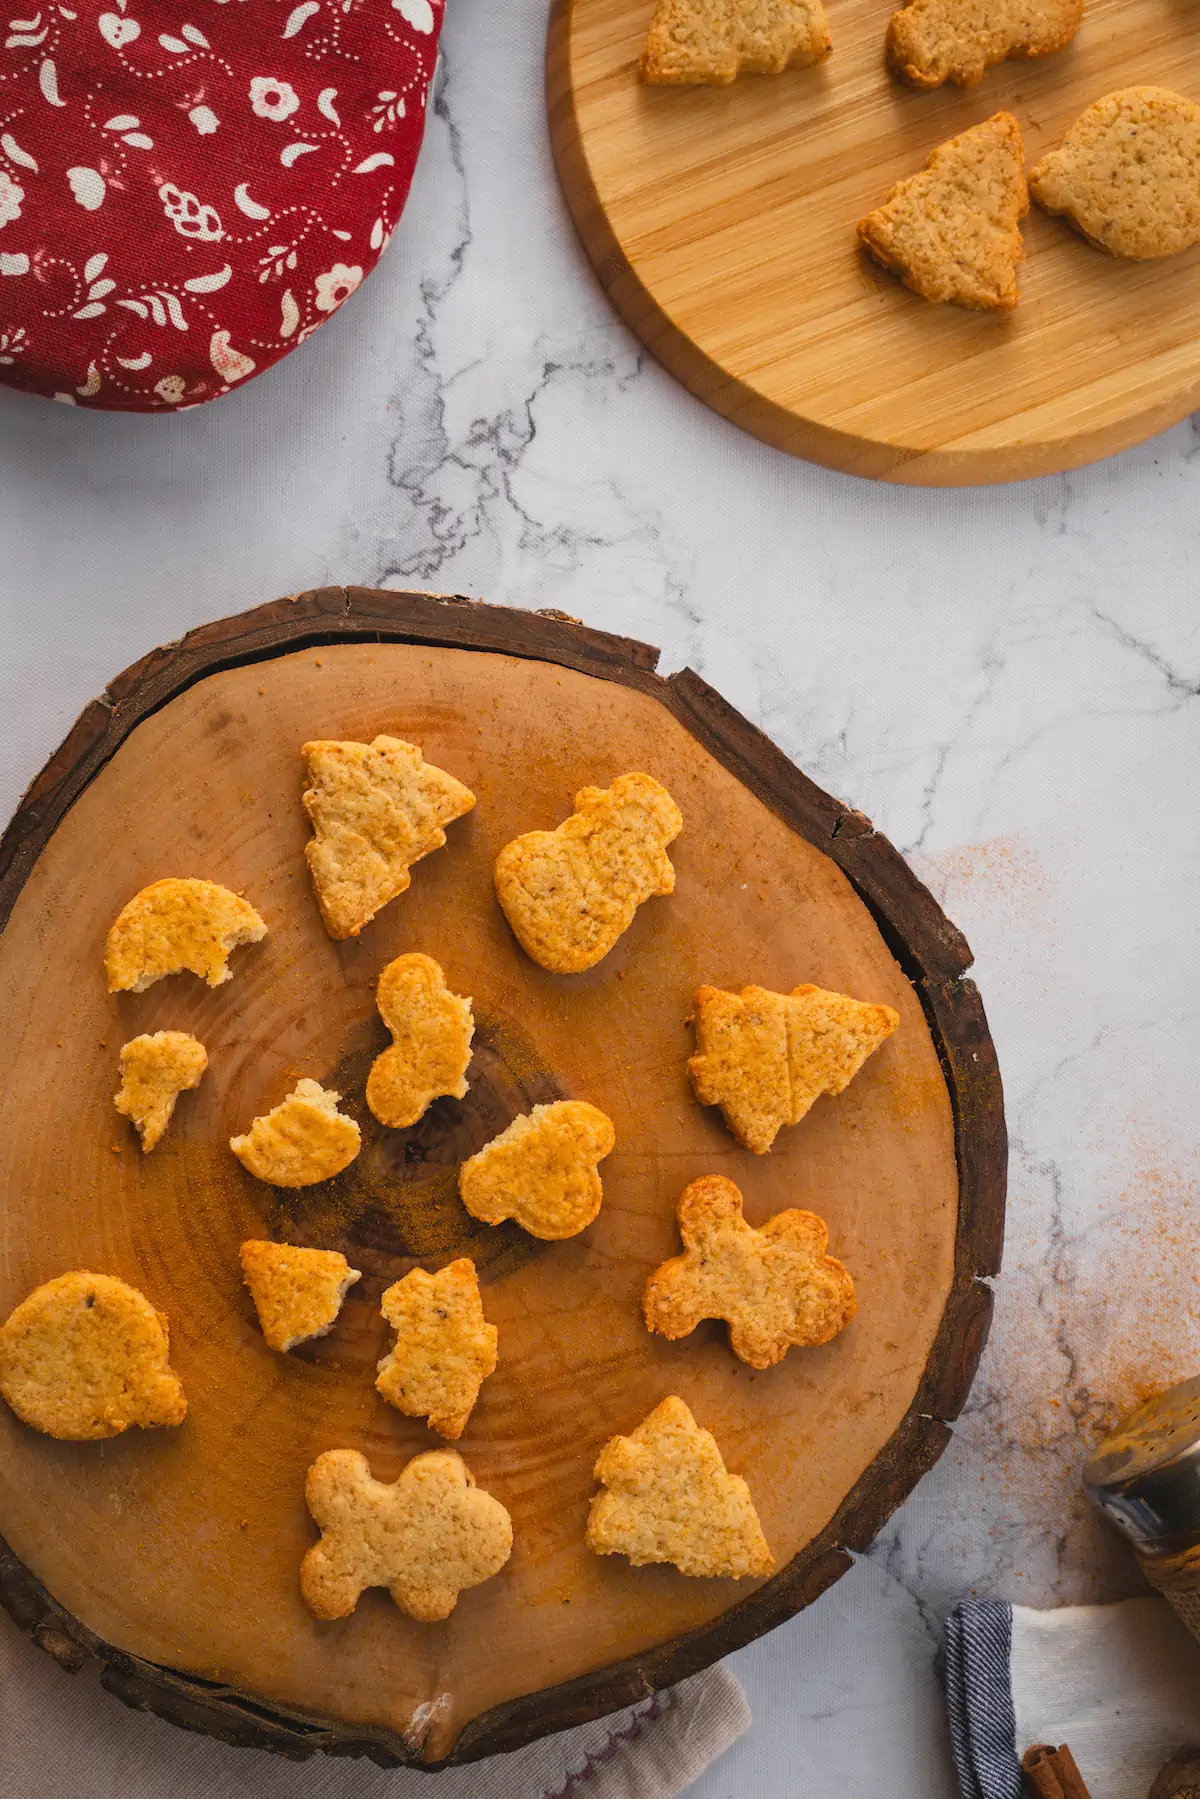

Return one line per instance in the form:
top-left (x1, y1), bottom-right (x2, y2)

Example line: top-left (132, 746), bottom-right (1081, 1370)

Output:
top-left (549, 0), bottom-right (1200, 486)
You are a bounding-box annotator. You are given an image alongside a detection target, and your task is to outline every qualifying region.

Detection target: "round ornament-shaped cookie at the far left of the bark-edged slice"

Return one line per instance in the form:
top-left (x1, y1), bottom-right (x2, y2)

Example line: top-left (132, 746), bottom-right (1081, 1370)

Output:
top-left (0, 1270), bottom-right (187, 1443)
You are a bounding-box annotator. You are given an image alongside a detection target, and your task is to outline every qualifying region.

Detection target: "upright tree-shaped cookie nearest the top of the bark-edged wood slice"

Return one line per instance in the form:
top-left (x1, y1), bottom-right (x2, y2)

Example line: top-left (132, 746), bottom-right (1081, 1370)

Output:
top-left (300, 738), bottom-right (475, 937)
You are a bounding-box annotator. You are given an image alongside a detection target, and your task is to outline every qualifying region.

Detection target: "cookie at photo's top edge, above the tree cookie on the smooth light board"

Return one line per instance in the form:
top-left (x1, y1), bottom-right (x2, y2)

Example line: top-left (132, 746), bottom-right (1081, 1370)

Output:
top-left (887, 0), bottom-right (1083, 88)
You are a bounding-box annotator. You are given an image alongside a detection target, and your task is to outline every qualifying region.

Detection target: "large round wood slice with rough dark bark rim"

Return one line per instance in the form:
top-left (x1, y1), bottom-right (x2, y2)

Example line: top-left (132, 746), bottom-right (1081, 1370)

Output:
top-left (0, 588), bottom-right (1004, 1765)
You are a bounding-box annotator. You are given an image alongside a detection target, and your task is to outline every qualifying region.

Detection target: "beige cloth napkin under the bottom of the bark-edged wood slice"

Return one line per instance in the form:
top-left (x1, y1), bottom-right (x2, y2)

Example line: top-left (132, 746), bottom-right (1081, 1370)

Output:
top-left (0, 1612), bottom-right (750, 1799)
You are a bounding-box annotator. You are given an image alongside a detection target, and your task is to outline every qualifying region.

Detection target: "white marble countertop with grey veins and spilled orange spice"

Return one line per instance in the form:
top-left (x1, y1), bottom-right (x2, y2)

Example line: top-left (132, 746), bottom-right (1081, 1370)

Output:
top-left (0, 0), bottom-right (1200, 1799)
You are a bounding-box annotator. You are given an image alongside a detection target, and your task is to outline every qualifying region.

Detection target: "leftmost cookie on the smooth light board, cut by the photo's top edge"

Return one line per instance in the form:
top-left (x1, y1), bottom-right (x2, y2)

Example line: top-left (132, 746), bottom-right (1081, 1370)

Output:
top-left (637, 0), bottom-right (829, 88)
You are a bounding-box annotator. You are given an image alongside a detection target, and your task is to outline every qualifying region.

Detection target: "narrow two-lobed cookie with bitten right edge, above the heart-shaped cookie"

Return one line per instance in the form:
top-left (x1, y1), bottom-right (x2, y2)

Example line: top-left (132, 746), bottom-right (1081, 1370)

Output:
top-left (367, 955), bottom-right (475, 1130)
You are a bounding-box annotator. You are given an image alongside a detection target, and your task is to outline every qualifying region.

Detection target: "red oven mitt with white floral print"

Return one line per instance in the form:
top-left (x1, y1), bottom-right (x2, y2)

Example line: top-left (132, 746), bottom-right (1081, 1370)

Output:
top-left (0, 0), bottom-right (443, 412)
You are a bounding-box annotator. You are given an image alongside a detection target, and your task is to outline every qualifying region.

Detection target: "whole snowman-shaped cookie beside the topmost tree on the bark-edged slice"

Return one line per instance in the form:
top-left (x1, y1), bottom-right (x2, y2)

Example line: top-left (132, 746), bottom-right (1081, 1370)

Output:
top-left (495, 774), bottom-right (684, 975)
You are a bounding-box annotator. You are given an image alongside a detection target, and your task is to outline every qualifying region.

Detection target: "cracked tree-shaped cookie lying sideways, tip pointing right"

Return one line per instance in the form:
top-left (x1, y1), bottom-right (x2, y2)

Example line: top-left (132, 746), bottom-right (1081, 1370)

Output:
top-left (687, 982), bottom-right (900, 1155)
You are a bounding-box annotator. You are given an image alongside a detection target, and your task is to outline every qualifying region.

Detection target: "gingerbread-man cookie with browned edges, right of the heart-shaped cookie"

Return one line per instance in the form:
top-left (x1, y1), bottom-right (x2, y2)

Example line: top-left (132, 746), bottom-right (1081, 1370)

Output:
top-left (642, 1175), bottom-right (855, 1367)
